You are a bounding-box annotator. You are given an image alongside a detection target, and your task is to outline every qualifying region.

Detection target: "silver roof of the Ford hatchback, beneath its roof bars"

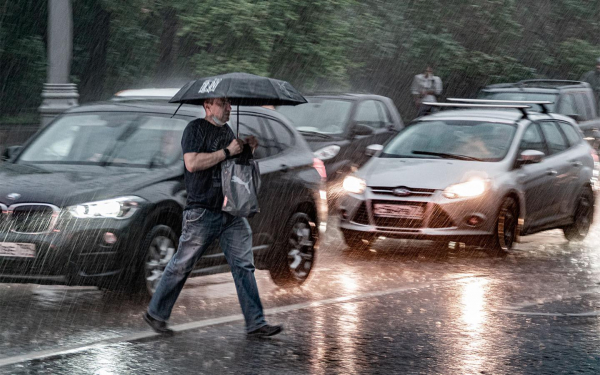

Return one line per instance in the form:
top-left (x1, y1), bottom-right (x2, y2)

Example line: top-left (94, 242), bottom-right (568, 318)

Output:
top-left (416, 109), bottom-right (549, 124)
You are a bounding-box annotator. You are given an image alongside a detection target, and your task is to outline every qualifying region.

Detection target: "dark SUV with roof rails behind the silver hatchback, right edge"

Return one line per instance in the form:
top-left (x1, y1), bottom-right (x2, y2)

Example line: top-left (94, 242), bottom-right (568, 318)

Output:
top-left (479, 79), bottom-right (600, 149)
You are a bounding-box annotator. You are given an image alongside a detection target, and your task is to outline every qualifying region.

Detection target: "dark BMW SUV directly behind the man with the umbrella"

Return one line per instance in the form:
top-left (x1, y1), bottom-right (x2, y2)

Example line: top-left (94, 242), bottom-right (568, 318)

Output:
top-left (0, 102), bottom-right (327, 293)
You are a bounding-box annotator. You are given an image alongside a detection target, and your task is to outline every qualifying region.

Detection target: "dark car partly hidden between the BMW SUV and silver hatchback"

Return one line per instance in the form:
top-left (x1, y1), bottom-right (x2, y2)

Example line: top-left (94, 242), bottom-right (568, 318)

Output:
top-left (277, 94), bottom-right (404, 191)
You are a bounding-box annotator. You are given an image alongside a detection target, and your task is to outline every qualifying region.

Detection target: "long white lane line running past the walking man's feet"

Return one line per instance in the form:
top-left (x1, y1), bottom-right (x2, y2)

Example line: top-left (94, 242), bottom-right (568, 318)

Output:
top-left (0, 275), bottom-right (480, 367)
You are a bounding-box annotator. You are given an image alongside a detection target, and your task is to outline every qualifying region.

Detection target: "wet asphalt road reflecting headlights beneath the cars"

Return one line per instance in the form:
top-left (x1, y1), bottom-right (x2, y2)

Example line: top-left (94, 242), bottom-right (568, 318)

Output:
top-left (0, 214), bottom-right (600, 374)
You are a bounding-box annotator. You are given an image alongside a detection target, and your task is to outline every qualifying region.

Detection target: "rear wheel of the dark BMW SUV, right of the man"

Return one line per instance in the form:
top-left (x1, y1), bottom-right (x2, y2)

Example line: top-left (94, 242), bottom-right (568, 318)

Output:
top-left (269, 212), bottom-right (318, 287)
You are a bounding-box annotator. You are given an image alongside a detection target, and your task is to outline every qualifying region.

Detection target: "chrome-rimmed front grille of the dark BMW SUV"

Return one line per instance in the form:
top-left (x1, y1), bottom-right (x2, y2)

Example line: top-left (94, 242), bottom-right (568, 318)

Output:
top-left (0, 203), bottom-right (60, 233)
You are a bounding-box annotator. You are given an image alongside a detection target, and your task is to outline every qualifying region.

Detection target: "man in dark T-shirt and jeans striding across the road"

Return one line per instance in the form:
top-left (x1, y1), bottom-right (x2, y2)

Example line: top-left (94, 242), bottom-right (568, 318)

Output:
top-left (144, 98), bottom-right (282, 337)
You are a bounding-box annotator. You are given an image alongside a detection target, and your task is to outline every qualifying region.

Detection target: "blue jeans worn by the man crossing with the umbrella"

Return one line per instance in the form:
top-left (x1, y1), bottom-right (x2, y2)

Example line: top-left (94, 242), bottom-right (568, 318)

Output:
top-left (148, 208), bottom-right (267, 332)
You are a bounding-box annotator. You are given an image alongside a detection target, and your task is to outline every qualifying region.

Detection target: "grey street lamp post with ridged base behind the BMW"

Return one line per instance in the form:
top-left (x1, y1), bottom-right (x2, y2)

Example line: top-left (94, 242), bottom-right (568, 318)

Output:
top-left (39, 0), bottom-right (79, 127)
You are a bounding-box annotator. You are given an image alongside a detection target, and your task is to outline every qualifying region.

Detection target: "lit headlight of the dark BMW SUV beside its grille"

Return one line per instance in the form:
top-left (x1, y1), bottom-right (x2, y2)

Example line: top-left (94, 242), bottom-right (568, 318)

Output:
top-left (67, 196), bottom-right (145, 219)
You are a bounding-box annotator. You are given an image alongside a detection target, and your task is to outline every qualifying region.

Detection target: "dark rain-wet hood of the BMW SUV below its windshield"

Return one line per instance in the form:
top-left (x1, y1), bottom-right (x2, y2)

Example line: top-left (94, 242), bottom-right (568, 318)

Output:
top-left (0, 163), bottom-right (183, 207)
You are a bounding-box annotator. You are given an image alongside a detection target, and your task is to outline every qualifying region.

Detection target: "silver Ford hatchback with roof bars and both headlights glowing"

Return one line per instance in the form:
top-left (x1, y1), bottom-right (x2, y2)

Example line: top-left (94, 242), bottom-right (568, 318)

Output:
top-left (339, 106), bottom-right (598, 251)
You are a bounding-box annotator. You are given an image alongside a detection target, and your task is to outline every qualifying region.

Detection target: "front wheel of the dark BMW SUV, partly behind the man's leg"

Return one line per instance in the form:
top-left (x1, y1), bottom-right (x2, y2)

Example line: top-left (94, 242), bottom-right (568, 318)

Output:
top-left (138, 225), bottom-right (178, 296)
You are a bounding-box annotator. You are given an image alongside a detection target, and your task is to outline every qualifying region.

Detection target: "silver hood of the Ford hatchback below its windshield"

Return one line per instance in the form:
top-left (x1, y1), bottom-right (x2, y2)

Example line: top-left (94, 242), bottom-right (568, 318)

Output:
top-left (357, 158), bottom-right (502, 190)
